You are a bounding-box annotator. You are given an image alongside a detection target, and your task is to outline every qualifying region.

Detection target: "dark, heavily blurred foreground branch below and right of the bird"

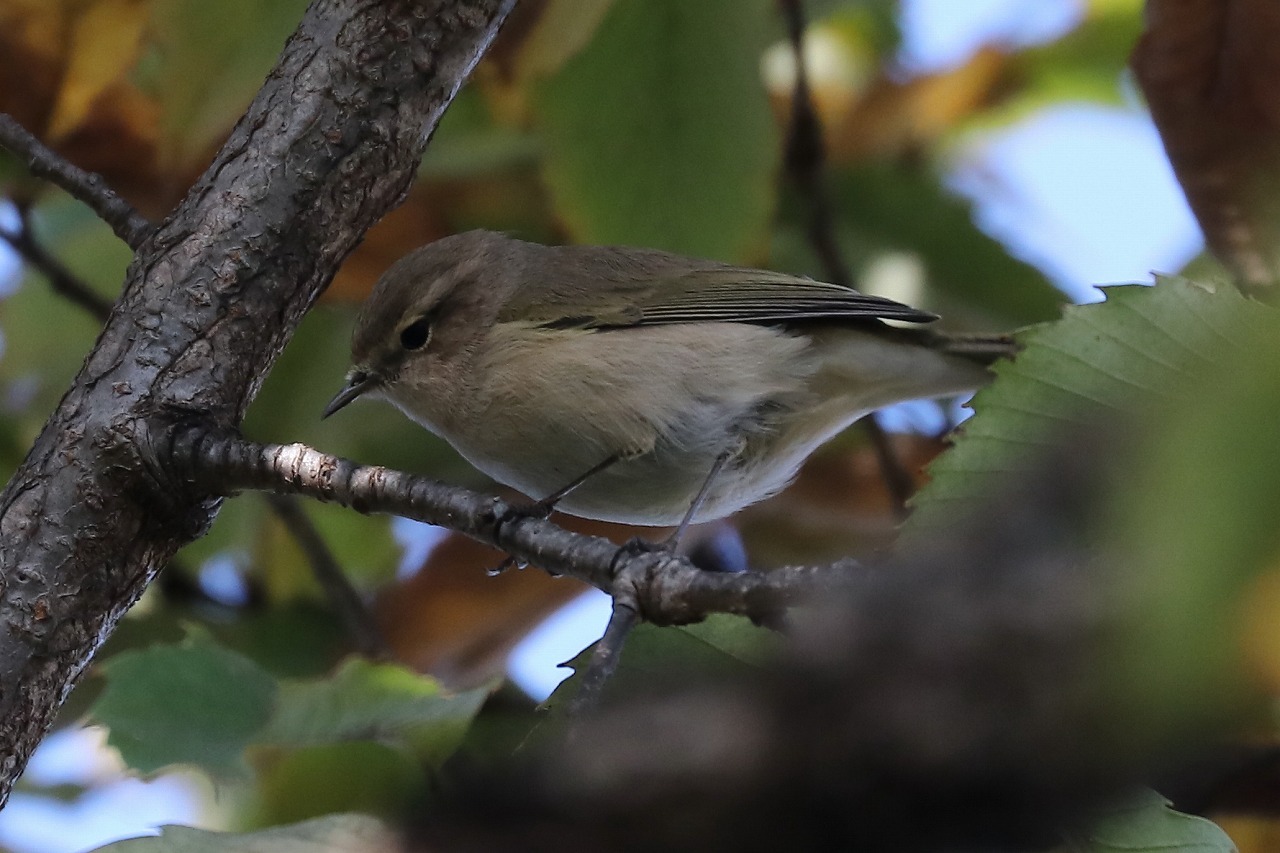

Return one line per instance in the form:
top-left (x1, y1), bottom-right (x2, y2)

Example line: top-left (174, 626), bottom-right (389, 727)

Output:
top-left (410, 440), bottom-right (1189, 853)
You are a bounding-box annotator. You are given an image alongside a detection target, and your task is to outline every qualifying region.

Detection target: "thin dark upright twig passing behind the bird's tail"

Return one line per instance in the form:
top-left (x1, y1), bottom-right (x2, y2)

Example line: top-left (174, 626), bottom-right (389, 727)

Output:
top-left (778, 0), bottom-right (915, 516)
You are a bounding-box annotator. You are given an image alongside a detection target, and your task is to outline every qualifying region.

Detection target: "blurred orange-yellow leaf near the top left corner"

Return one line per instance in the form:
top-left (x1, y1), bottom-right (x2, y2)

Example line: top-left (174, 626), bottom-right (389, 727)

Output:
top-left (47, 0), bottom-right (151, 140)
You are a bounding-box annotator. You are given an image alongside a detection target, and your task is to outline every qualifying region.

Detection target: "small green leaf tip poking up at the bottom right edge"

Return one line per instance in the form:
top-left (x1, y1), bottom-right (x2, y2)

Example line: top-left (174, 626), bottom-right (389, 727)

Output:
top-left (1068, 790), bottom-right (1236, 853)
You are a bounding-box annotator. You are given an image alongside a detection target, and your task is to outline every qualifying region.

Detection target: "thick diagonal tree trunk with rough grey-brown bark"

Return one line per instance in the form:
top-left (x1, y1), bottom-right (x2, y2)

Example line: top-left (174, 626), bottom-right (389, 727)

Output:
top-left (0, 0), bottom-right (515, 802)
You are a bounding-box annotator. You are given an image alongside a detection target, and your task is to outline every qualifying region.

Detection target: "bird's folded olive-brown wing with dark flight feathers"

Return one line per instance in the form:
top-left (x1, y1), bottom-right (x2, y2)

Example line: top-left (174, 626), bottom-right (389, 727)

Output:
top-left (512, 266), bottom-right (937, 329)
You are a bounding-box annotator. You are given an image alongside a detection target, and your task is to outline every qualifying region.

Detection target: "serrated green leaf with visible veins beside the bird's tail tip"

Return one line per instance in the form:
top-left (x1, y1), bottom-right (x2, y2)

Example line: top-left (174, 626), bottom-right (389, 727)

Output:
top-left (904, 278), bottom-right (1275, 540)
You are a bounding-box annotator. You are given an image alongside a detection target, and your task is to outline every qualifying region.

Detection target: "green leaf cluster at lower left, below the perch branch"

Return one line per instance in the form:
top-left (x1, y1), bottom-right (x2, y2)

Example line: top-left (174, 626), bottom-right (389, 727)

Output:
top-left (90, 631), bottom-right (488, 824)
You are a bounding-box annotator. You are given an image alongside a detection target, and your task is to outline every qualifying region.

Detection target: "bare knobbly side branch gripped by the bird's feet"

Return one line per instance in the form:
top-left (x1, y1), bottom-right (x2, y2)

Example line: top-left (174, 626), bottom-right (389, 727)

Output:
top-left (162, 425), bottom-right (851, 624)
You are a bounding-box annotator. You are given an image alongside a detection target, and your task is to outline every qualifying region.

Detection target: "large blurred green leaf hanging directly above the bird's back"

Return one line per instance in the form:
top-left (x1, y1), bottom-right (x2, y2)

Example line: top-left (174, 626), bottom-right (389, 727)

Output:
top-left (536, 0), bottom-right (778, 260)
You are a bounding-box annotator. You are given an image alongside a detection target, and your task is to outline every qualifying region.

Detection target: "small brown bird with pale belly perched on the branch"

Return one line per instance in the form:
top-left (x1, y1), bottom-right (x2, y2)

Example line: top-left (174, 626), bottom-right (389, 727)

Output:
top-left (325, 231), bottom-right (1011, 529)
